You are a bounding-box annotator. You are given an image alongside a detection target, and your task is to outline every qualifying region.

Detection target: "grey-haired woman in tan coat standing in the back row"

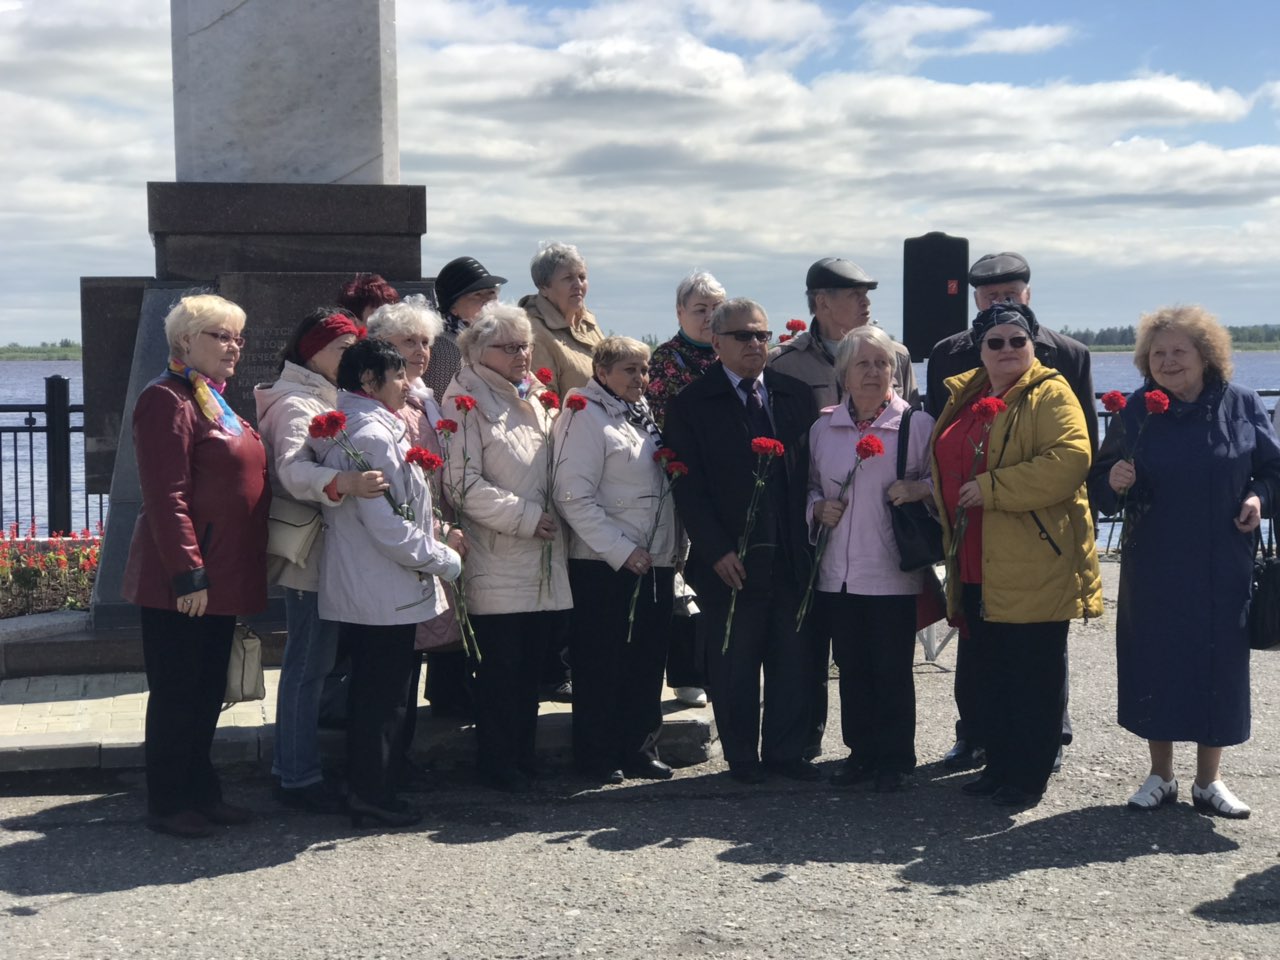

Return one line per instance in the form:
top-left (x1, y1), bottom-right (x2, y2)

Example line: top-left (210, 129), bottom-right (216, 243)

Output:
top-left (520, 243), bottom-right (604, 394)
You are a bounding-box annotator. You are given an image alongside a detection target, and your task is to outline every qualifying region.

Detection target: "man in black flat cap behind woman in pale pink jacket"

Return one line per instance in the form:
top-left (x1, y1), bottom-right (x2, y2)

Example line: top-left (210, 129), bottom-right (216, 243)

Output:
top-left (769, 257), bottom-right (920, 758)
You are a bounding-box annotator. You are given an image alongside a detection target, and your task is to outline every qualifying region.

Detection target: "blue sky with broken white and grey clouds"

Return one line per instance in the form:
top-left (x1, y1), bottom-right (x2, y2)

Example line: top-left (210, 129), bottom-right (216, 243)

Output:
top-left (0, 0), bottom-right (1280, 343)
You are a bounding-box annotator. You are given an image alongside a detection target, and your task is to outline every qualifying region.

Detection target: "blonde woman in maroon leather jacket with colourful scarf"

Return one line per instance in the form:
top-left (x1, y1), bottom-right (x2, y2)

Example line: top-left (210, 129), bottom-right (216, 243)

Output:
top-left (124, 294), bottom-right (271, 837)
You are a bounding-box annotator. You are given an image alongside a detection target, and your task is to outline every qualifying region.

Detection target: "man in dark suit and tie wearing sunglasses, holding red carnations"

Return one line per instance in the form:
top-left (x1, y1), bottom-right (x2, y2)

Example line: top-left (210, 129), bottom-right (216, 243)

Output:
top-left (663, 298), bottom-right (820, 783)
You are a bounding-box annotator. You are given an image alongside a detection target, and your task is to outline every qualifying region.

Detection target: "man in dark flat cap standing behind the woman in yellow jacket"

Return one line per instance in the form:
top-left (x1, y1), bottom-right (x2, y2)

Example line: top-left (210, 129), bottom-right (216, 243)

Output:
top-left (924, 252), bottom-right (1098, 771)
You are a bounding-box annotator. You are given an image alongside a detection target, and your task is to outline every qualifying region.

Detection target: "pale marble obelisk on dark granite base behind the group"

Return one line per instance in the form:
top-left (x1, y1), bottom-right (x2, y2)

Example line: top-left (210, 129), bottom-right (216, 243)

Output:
top-left (88, 0), bottom-right (429, 628)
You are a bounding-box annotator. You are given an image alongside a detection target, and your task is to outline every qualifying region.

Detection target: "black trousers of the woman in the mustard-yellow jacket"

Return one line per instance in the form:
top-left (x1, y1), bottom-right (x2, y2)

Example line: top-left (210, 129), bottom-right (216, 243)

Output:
top-left (963, 584), bottom-right (1069, 794)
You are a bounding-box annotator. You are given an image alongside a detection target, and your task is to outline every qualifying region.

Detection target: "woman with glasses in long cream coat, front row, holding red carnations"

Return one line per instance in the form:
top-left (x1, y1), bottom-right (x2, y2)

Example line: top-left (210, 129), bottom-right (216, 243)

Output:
top-left (440, 303), bottom-right (572, 791)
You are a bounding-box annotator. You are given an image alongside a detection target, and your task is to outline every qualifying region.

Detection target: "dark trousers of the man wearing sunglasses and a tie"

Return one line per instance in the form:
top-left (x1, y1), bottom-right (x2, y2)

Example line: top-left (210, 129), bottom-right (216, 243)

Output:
top-left (698, 563), bottom-right (813, 763)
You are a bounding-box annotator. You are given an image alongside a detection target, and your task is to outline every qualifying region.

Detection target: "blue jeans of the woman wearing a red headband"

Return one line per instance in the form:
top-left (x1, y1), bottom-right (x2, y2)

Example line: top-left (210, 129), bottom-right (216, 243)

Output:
top-left (271, 590), bottom-right (338, 788)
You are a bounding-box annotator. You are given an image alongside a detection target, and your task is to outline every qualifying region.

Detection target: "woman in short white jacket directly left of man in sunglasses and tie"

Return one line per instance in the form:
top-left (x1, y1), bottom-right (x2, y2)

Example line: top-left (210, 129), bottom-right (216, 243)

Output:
top-left (556, 337), bottom-right (677, 783)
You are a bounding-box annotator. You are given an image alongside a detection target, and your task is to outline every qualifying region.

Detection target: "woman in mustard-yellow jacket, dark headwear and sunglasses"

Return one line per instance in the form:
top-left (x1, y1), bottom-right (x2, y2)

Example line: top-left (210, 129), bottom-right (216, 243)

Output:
top-left (933, 303), bottom-right (1102, 806)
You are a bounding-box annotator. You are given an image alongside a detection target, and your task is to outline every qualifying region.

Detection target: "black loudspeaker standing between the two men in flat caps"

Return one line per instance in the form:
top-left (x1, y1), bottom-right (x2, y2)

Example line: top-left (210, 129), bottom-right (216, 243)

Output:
top-left (902, 232), bottom-right (972, 361)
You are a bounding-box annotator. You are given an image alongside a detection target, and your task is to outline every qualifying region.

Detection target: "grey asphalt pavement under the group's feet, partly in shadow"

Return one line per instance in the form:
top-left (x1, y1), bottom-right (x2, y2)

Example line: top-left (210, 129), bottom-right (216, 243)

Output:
top-left (0, 564), bottom-right (1280, 960)
